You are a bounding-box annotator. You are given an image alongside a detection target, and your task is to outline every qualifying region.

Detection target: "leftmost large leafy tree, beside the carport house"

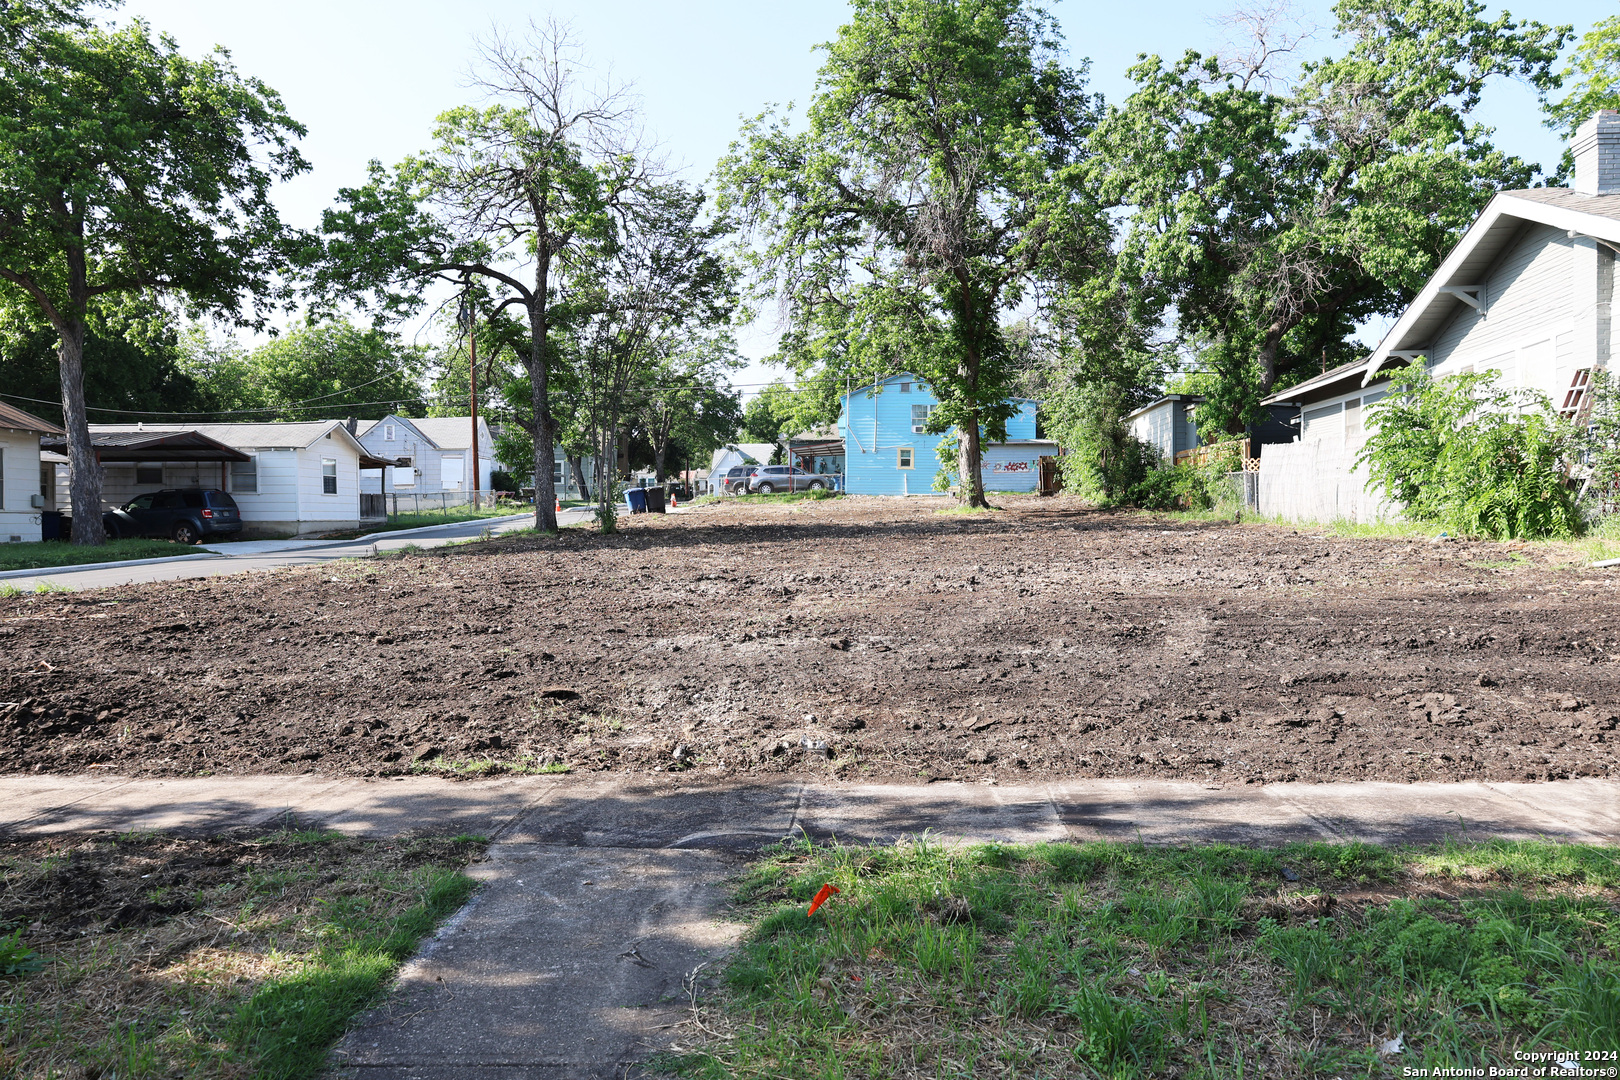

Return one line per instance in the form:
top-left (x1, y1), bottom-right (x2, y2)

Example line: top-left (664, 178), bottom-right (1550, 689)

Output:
top-left (0, 0), bottom-right (306, 544)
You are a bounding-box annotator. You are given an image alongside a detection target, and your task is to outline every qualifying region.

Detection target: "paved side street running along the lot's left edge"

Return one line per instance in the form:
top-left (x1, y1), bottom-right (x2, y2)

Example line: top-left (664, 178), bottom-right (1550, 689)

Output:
top-left (5, 507), bottom-right (591, 593)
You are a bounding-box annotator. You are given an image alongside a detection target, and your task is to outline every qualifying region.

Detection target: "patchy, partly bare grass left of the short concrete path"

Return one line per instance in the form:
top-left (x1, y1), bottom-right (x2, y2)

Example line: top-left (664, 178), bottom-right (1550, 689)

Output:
top-left (0, 829), bottom-right (484, 1080)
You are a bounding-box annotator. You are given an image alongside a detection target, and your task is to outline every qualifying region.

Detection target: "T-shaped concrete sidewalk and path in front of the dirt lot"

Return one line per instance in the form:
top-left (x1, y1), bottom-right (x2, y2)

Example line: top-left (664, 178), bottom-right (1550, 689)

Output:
top-left (0, 776), bottom-right (1620, 1080)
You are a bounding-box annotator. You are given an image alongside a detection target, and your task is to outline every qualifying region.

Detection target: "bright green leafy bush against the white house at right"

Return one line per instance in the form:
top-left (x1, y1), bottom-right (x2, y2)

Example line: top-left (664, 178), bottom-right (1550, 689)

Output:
top-left (1358, 364), bottom-right (1581, 538)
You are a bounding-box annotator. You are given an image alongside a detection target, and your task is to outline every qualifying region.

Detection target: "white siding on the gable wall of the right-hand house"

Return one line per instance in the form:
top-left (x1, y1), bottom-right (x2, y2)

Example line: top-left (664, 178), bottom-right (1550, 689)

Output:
top-left (1427, 222), bottom-right (1574, 398)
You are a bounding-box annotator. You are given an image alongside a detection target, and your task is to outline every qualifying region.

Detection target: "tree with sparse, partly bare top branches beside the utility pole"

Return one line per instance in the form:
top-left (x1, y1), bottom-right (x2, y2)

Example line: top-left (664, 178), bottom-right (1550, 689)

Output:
top-left (314, 23), bottom-right (648, 533)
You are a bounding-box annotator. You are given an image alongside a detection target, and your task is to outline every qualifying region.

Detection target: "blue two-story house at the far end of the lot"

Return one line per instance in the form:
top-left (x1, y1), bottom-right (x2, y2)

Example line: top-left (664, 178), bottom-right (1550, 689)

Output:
top-left (838, 372), bottom-right (1058, 495)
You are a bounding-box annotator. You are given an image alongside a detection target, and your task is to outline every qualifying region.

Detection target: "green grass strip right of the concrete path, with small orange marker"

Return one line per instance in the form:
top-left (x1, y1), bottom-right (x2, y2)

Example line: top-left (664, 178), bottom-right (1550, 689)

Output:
top-left (656, 842), bottom-right (1620, 1080)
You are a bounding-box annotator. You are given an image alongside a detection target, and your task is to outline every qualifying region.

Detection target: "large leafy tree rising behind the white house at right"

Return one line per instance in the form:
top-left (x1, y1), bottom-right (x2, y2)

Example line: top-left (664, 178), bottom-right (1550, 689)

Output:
top-left (1092, 0), bottom-right (1568, 431)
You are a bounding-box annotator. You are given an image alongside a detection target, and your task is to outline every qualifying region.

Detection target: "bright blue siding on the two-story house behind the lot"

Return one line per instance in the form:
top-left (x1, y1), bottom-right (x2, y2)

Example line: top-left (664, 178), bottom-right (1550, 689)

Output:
top-left (838, 374), bottom-right (1035, 495)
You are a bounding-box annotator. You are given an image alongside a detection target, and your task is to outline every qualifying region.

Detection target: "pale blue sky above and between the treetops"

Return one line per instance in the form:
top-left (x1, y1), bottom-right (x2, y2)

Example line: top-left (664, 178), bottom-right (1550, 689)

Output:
top-left (115, 0), bottom-right (1620, 389)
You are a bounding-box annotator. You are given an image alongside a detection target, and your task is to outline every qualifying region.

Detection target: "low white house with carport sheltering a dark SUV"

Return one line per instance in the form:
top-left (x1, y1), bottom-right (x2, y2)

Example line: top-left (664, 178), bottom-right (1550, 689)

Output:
top-left (67, 419), bottom-right (371, 538)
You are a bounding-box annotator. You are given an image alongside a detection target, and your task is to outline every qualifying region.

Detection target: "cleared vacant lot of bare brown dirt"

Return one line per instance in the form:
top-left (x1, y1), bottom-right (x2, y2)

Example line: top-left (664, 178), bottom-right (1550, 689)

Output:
top-left (0, 499), bottom-right (1620, 782)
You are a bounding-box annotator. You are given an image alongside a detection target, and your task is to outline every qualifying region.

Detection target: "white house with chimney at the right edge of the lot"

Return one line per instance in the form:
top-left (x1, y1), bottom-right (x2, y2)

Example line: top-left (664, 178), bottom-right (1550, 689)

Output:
top-left (1259, 110), bottom-right (1620, 520)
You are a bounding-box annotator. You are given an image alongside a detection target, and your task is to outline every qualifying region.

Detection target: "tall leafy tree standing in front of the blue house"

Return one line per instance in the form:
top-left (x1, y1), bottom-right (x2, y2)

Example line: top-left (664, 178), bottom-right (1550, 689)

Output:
top-left (721, 0), bottom-right (1106, 507)
